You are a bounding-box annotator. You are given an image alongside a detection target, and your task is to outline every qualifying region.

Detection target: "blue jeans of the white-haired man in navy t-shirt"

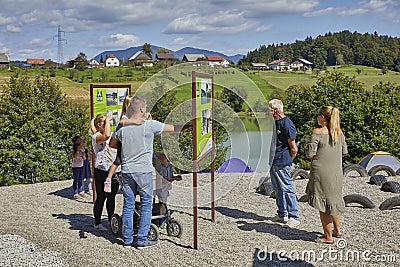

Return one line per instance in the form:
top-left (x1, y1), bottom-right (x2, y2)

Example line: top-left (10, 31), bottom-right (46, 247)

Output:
top-left (269, 165), bottom-right (299, 220)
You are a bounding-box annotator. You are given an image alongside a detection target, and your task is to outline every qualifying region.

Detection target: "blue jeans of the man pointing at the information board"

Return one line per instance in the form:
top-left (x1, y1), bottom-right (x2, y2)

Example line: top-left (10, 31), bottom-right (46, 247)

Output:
top-left (122, 172), bottom-right (153, 245)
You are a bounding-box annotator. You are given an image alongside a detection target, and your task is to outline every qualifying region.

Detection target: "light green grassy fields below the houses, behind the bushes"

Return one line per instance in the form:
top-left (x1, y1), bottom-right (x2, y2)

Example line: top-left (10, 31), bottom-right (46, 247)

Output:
top-left (0, 64), bottom-right (400, 105)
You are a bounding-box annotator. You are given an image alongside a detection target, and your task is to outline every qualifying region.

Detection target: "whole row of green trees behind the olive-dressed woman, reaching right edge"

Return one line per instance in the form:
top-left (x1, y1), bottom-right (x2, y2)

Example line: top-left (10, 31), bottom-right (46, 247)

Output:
top-left (271, 72), bottom-right (400, 169)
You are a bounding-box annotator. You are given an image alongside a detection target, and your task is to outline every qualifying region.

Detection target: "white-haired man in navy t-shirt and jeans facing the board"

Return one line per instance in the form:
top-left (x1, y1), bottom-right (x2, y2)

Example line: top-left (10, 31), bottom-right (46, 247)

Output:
top-left (269, 99), bottom-right (300, 228)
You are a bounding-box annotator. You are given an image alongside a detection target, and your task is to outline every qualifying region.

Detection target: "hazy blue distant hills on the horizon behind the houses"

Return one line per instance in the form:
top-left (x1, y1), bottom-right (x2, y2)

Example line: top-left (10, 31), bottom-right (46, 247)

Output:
top-left (94, 45), bottom-right (244, 64)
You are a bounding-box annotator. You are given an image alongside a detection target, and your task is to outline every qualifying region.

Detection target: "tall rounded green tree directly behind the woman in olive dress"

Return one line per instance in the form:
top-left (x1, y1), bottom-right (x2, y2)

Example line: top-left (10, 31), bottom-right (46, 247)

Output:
top-left (284, 72), bottom-right (368, 168)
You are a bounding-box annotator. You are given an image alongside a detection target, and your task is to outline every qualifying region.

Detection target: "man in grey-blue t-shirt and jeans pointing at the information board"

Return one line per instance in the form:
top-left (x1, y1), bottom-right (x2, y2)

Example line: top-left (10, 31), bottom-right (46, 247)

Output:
top-left (110, 96), bottom-right (190, 249)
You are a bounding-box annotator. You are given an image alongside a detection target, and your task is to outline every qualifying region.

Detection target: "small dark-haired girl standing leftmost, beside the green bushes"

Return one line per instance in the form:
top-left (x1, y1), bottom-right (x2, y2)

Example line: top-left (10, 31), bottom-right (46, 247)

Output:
top-left (72, 136), bottom-right (86, 199)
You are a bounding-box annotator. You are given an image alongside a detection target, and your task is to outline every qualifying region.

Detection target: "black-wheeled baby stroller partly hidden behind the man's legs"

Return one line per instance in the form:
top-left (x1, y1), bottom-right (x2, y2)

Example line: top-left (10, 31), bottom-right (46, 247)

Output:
top-left (110, 201), bottom-right (183, 241)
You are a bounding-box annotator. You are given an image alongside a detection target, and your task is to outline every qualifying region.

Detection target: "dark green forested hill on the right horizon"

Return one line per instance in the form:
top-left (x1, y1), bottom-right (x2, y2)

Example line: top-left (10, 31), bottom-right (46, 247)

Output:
top-left (238, 30), bottom-right (400, 71)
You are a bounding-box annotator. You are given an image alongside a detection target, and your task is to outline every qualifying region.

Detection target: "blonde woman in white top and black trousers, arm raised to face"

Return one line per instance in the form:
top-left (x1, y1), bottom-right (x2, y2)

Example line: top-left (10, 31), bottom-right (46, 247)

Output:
top-left (91, 114), bottom-right (119, 231)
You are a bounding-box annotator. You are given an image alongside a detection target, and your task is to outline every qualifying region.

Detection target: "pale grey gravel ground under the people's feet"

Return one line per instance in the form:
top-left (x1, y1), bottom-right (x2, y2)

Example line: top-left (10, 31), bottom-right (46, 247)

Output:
top-left (0, 173), bottom-right (400, 266)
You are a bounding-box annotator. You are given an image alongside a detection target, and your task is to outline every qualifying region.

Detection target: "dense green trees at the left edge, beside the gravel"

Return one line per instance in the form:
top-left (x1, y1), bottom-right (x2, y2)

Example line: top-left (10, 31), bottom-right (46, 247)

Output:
top-left (0, 75), bottom-right (89, 185)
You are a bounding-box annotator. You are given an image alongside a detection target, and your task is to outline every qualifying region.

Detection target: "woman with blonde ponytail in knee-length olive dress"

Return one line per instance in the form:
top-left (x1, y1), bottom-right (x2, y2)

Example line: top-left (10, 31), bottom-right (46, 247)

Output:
top-left (306, 106), bottom-right (347, 244)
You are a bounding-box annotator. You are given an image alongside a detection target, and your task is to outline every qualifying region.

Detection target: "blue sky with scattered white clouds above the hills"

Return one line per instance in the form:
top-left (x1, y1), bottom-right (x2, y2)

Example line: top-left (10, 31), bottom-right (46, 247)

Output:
top-left (0, 0), bottom-right (400, 62)
